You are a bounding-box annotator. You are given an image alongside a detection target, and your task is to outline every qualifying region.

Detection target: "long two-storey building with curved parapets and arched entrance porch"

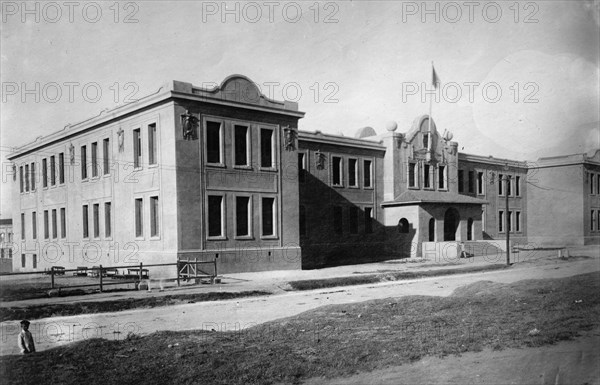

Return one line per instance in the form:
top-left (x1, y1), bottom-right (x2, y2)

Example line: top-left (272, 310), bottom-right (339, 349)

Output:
top-left (9, 75), bottom-right (600, 274)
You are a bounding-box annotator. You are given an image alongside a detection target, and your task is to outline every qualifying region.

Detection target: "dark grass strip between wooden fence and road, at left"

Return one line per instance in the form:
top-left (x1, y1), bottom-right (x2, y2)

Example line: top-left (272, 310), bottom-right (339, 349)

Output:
top-left (0, 290), bottom-right (271, 321)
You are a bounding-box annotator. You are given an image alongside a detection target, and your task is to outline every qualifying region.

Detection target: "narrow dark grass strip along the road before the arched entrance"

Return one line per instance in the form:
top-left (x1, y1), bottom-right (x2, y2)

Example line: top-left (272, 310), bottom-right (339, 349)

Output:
top-left (288, 264), bottom-right (508, 290)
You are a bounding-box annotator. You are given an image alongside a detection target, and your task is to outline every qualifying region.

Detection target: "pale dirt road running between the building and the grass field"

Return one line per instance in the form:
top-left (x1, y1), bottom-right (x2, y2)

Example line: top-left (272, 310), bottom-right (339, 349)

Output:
top-left (0, 258), bottom-right (600, 355)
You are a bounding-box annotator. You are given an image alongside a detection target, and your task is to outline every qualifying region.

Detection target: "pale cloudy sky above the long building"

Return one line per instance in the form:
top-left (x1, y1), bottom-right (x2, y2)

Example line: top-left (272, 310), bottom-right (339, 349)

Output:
top-left (0, 0), bottom-right (600, 217)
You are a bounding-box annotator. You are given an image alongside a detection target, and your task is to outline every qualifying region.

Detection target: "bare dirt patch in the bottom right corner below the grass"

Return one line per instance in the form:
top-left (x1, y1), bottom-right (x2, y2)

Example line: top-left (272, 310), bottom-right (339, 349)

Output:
top-left (304, 330), bottom-right (600, 385)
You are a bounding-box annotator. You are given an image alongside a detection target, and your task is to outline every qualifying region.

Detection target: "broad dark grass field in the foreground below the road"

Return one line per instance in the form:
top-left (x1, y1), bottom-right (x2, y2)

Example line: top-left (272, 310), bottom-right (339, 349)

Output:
top-left (0, 273), bottom-right (600, 385)
